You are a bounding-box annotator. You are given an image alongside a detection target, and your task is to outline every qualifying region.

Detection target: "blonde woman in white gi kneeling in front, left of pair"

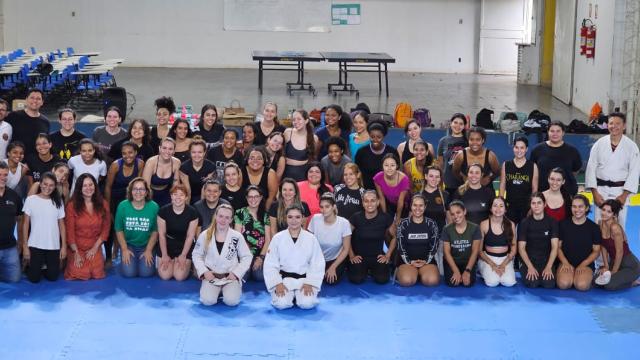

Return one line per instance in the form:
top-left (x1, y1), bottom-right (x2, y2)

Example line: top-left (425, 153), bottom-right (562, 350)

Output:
top-left (192, 204), bottom-right (253, 306)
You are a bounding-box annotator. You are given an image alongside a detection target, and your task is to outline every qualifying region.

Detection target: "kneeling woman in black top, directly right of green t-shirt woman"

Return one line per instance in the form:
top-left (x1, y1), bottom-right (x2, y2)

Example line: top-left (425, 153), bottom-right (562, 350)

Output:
top-left (156, 184), bottom-right (198, 281)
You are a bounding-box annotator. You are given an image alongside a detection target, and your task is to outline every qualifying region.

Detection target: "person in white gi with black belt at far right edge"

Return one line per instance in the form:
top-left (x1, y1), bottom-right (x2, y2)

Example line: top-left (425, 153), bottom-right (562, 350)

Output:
top-left (585, 112), bottom-right (640, 229)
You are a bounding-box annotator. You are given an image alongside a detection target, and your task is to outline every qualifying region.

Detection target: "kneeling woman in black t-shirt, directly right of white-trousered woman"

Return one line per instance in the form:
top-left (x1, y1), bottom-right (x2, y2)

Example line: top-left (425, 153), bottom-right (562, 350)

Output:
top-left (518, 192), bottom-right (558, 289)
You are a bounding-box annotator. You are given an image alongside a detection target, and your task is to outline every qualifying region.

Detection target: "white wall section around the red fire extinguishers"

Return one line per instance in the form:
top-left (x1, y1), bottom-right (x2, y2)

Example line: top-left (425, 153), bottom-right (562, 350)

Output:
top-left (568, 0), bottom-right (615, 114)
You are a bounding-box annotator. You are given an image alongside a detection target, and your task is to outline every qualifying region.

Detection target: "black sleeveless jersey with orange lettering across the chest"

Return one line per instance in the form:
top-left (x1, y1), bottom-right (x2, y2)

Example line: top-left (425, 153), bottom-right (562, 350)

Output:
top-left (504, 160), bottom-right (533, 209)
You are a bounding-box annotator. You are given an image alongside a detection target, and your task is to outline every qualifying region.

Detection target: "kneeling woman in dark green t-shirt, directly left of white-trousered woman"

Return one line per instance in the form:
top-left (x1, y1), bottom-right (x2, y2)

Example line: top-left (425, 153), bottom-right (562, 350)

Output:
top-left (441, 200), bottom-right (482, 286)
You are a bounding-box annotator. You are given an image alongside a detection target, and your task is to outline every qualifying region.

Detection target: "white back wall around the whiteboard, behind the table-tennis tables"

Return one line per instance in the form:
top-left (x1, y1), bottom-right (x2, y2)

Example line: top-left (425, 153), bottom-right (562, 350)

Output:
top-left (3, 0), bottom-right (480, 73)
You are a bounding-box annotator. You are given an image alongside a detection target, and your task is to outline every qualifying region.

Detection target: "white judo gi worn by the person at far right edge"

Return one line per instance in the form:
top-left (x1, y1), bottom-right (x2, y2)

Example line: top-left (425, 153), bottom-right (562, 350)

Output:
top-left (585, 135), bottom-right (640, 228)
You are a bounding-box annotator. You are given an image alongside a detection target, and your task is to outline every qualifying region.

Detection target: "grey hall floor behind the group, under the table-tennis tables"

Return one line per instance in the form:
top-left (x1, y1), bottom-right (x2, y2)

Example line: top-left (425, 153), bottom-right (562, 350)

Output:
top-left (60, 66), bottom-right (586, 126)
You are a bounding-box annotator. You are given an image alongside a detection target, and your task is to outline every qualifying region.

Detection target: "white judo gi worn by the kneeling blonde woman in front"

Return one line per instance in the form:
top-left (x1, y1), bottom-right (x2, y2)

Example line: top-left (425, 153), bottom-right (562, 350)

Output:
top-left (191, 229), bottom-right (253, 306)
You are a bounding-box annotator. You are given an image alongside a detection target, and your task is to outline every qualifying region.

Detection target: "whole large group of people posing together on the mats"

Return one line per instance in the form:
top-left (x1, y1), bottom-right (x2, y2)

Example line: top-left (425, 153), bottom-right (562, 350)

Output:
top-left (0, 90), bottom-right (640, 309)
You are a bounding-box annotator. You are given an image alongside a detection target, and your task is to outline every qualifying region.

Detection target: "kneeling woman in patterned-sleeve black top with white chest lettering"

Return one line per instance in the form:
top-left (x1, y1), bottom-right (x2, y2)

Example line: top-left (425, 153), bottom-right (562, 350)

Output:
top-left (397, 194), bottom-right (440, 286)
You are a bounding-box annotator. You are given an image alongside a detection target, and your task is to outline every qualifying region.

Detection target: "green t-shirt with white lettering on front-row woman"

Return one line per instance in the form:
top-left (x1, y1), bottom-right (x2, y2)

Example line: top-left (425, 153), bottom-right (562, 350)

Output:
top-left (113, 200), bottom-right (158, 247)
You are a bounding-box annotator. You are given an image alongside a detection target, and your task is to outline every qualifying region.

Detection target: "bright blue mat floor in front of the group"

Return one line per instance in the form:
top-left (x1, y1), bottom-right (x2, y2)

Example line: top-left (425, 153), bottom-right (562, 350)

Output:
top-left (0, 207), bottom-right (640, 360)
